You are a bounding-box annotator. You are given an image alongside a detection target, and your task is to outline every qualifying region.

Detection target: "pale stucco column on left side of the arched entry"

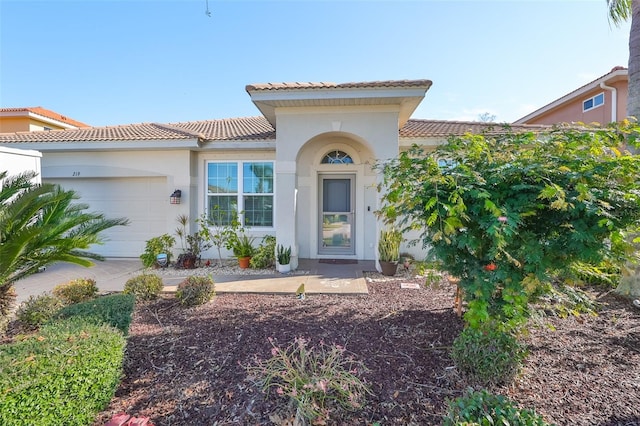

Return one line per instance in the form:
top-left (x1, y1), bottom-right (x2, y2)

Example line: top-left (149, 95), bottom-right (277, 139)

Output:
top-left (275, 160), bottom-right (298, 269)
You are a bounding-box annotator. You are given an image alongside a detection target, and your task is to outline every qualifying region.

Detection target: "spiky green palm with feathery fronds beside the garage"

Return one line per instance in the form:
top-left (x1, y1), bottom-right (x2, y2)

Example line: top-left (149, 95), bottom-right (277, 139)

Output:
top-left (0, 171), bottom-right (128, 316)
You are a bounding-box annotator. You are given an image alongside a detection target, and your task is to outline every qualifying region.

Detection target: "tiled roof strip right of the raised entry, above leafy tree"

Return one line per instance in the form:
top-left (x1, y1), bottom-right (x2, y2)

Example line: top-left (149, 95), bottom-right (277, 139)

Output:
top-left (400, 120), bottom-right (551, 138)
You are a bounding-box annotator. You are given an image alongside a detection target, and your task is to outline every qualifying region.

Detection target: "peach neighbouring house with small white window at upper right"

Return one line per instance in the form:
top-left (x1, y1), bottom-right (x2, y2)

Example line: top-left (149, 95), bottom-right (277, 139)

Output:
top-left (514, 67), bottom-right (629, 124)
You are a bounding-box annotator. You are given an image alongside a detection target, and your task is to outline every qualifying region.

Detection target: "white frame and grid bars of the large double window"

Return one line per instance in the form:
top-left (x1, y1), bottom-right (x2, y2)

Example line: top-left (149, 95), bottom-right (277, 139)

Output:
top-left (205, 160), bottom-right (276, 231)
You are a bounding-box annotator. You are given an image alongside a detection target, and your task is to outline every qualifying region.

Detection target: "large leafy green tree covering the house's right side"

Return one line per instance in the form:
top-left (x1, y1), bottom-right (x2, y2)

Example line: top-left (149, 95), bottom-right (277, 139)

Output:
top-left (378, 122), bottom-right (640, 327)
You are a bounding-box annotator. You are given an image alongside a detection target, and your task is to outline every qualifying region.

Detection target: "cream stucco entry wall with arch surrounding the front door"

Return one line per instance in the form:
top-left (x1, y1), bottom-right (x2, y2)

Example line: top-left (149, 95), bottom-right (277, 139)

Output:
top-left (276, 106), bottom-right (399, 265)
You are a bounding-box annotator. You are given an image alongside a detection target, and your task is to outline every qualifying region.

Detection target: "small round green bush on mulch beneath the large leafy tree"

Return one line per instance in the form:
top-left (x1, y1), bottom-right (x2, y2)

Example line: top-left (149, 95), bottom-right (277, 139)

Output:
top-left (451, 325), bottom-right (526, 386)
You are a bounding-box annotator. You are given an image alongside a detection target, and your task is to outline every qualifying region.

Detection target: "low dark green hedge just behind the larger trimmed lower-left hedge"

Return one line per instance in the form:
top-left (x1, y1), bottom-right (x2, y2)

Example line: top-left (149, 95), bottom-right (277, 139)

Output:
top-left (56, 294), bottom-right (135, 335)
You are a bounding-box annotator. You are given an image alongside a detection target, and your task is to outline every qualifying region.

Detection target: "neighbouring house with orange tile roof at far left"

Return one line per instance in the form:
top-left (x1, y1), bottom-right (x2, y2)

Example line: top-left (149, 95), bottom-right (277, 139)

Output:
top-left (0, 107), bottom-right (89, 133)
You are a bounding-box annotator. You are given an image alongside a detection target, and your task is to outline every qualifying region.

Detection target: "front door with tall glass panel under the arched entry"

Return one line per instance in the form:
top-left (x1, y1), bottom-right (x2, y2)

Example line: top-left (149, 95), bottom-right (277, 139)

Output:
top-left (318, 175), bottom-right (356, 255)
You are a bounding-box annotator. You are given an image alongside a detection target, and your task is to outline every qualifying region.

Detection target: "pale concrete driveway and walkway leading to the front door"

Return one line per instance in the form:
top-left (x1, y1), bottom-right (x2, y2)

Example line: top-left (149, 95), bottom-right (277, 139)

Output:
top-left (14, 258), bottom-right (375, 304)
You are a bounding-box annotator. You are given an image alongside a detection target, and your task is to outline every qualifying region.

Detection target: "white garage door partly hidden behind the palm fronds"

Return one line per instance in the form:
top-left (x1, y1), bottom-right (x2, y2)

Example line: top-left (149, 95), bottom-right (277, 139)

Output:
top-left (46, 177), bottom-right (169, 257)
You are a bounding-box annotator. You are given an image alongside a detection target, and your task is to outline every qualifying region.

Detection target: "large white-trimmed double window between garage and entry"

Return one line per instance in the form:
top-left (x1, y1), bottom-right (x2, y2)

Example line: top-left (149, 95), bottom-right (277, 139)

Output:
top-left (207, 161), bottom-right (274, 228)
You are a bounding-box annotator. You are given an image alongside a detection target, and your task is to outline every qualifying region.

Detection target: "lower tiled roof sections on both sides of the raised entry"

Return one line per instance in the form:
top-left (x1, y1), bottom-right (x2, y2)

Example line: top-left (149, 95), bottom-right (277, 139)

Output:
top-left (0, 116), bottom-right (550, 144)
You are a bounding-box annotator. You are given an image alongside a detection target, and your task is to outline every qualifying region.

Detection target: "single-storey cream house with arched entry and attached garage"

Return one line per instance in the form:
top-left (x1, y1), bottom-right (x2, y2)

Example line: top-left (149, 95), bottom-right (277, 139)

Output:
top-left (0, 80), bottom-right (539, 267)
